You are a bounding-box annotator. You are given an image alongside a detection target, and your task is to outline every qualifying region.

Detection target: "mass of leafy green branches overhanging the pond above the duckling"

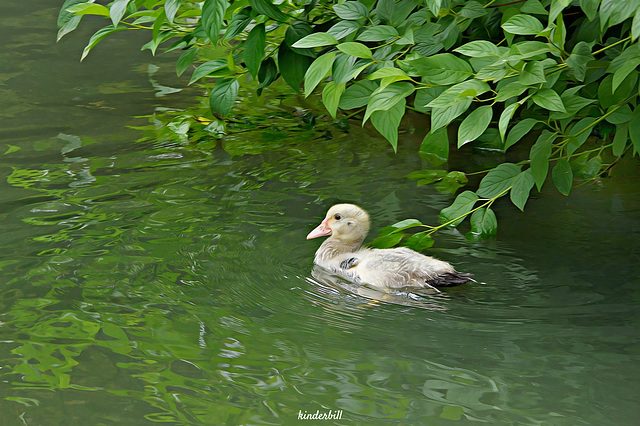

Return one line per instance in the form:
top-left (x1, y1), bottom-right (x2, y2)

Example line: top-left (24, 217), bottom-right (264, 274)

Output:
top-left (58, 0), bottom-right (640, 249)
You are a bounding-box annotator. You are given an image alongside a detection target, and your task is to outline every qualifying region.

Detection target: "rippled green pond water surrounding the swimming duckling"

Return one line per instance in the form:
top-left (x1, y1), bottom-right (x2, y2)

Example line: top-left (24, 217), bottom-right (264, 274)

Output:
top-left (0, 0), bottom-right (640, 425)
